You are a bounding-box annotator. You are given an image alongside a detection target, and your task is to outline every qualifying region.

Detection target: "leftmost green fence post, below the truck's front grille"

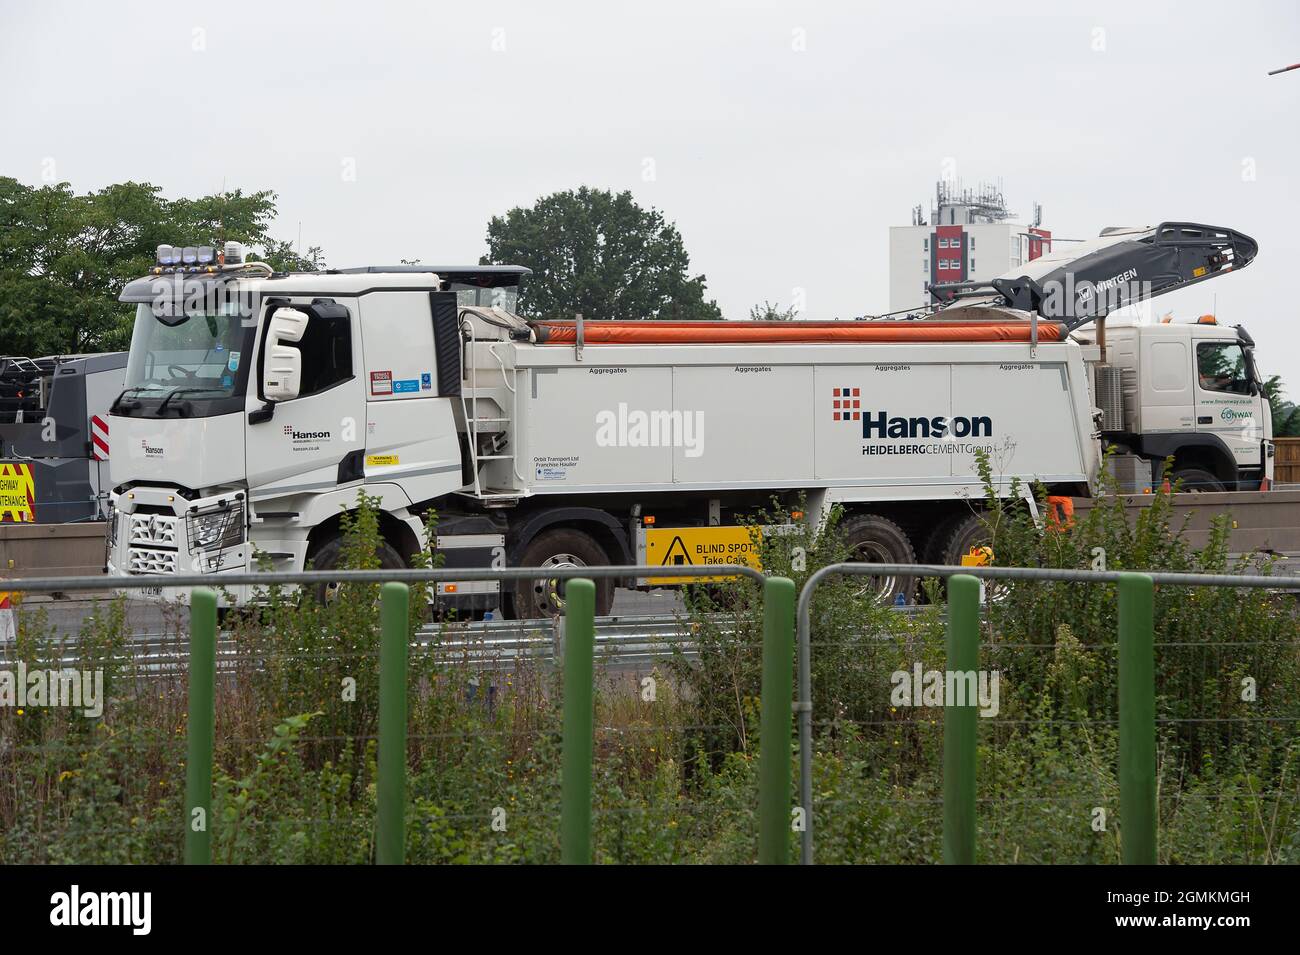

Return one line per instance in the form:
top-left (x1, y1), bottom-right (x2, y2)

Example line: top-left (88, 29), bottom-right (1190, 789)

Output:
top-left (185, 587), bottom-right (217, 865)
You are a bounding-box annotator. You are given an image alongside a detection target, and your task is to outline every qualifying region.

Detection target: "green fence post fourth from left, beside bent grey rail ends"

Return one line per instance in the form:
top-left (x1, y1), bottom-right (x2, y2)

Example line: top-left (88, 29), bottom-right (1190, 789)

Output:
top-left (758, 577), bottom-right (794, 865)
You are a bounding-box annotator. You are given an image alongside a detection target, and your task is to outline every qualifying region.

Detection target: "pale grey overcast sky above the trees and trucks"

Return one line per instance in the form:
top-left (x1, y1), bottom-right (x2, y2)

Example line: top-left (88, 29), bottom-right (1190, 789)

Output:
top-left (0, 0), bottom-right (1300, 384)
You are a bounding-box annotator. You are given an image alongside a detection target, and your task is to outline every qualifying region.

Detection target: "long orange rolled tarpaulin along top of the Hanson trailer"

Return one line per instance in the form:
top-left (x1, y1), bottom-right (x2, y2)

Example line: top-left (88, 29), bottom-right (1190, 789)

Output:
top-left (532, 321), bottom-right (1063, 344)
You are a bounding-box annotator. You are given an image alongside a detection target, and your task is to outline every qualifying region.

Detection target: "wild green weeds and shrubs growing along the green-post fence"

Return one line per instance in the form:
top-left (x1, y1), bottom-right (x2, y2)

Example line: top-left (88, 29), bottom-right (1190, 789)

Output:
top-left (0, 485), bottom-right (1300, 864)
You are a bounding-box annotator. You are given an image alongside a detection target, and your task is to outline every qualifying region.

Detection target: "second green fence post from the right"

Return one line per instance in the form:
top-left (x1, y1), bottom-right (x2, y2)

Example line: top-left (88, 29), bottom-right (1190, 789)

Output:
top-left (944, 574), bottom-right (979, 865)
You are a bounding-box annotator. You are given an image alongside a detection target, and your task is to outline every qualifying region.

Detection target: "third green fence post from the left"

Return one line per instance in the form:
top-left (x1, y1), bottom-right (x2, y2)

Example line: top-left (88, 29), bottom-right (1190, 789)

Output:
top-left (560, 577), bottom-right (595, 865)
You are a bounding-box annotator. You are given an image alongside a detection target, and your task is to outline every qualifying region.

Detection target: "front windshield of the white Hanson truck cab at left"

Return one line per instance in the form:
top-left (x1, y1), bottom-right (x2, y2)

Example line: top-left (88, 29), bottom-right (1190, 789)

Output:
top-left (113, 303), bottom-right (255, 417)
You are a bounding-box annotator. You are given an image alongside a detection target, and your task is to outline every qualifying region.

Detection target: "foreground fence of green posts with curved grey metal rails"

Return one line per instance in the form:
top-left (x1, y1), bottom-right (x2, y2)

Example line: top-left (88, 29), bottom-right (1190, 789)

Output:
top-left (7, 564), bottom-right (1300, 864)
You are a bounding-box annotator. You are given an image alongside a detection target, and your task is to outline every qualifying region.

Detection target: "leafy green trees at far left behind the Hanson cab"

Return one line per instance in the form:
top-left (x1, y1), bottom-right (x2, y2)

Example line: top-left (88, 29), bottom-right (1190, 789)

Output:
top-left (0, 177), bottom-right (324, 356)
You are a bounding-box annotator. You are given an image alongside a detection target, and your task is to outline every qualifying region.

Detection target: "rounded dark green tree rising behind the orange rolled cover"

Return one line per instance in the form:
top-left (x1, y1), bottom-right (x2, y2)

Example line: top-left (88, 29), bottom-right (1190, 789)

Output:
top-left (481, 186), bottom-right (722, 321)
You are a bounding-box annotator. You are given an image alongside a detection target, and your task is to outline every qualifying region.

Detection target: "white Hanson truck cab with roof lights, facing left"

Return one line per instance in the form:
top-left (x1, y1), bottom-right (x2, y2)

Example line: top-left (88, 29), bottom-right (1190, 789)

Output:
top-left (107, 243), bottom-right (528, 600)
